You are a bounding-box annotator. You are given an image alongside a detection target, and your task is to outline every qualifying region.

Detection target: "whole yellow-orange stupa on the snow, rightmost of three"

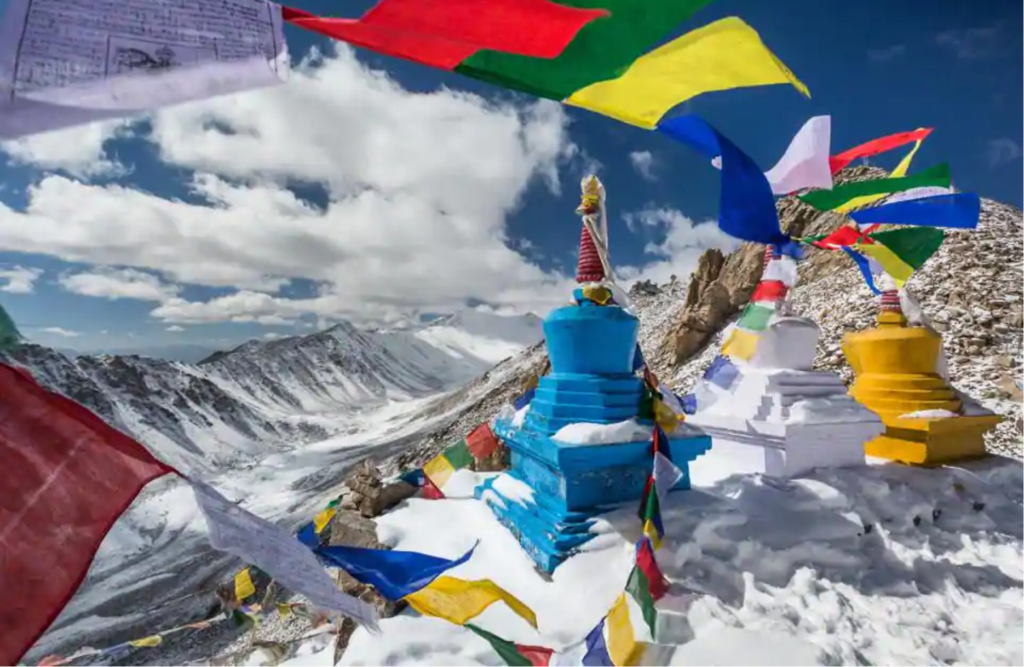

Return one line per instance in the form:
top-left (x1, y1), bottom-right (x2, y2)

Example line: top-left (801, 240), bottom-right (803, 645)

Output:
top-left (843, 290), bottom-right (1002, 465)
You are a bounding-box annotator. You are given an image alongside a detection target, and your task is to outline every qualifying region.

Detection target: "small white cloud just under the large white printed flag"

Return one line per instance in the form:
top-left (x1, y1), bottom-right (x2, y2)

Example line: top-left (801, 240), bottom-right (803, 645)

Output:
top-left (0, 120), bottom-right (132, 178)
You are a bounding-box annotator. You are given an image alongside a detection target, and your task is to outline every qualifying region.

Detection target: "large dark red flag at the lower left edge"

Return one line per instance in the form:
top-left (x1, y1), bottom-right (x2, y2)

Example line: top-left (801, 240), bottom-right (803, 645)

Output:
top-left (0, 364), bottom-right (175, 665)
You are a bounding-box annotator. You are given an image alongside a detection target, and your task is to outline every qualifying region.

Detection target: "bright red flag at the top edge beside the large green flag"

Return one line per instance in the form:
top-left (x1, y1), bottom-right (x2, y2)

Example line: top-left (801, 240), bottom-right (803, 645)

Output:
top-left (283, 0), bottom-right (608, 70)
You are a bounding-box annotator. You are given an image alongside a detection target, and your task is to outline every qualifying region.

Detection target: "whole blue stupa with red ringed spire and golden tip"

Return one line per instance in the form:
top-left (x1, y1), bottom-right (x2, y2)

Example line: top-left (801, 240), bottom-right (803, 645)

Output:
top-left (476, 176), bottom-right (711, 573)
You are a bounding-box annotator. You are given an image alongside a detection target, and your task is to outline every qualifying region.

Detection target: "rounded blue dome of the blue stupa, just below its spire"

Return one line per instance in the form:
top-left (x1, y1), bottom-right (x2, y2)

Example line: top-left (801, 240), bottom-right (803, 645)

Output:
top-left (544, 304), bottom-right (640, 375)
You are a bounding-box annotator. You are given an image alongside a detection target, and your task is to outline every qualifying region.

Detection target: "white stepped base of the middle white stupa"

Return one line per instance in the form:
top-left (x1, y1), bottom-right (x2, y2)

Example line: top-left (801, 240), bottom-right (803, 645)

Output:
top-left (687, 362), bottom-right (885, 484)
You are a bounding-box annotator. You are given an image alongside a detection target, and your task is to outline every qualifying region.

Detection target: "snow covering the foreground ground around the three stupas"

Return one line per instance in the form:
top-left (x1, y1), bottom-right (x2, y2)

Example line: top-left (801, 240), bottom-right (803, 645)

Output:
top-left (331, 459), bottom-right (1024, 665)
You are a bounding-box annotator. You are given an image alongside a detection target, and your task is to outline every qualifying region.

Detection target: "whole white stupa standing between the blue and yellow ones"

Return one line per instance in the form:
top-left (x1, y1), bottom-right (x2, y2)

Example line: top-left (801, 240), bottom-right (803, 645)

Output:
top-left (686, 246), bottom-right (885, 485)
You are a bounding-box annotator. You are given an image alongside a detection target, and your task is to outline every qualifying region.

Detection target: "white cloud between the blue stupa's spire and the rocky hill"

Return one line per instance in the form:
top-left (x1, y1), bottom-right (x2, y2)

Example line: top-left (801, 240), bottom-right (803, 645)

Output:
top-left (616, 208), bottom-right (739, 286)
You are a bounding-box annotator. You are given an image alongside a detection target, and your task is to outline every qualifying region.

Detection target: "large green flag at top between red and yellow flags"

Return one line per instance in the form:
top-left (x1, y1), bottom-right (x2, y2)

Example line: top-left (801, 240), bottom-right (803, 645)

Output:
top-left (455, 0), bottom-right (713, 101)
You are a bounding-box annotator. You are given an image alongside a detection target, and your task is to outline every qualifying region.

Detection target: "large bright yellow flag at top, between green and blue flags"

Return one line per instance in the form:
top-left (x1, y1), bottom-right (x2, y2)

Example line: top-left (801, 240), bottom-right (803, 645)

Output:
top-left (565, 17), bottom-right (810, 128)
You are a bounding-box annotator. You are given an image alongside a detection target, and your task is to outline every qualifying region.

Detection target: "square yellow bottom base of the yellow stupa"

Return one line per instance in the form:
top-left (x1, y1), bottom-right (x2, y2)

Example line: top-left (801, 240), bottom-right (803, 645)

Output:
top-left (864, 415), bottom-right (1002, 465)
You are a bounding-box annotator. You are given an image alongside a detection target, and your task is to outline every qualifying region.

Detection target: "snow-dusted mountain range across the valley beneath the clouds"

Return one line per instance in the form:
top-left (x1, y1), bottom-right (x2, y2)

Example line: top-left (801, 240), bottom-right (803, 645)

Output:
top-left (11, 311), bottom-right (542, 474)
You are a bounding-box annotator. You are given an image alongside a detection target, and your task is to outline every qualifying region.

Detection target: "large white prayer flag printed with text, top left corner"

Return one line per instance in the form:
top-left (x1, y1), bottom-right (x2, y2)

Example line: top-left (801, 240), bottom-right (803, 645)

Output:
top-left (0, 0), bottom-right (288, 139)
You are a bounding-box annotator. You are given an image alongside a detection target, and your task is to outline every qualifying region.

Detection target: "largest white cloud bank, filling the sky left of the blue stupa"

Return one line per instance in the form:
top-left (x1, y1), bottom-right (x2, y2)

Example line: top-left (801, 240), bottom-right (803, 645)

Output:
top-left (0, 45), bottom-right (575, 324)
